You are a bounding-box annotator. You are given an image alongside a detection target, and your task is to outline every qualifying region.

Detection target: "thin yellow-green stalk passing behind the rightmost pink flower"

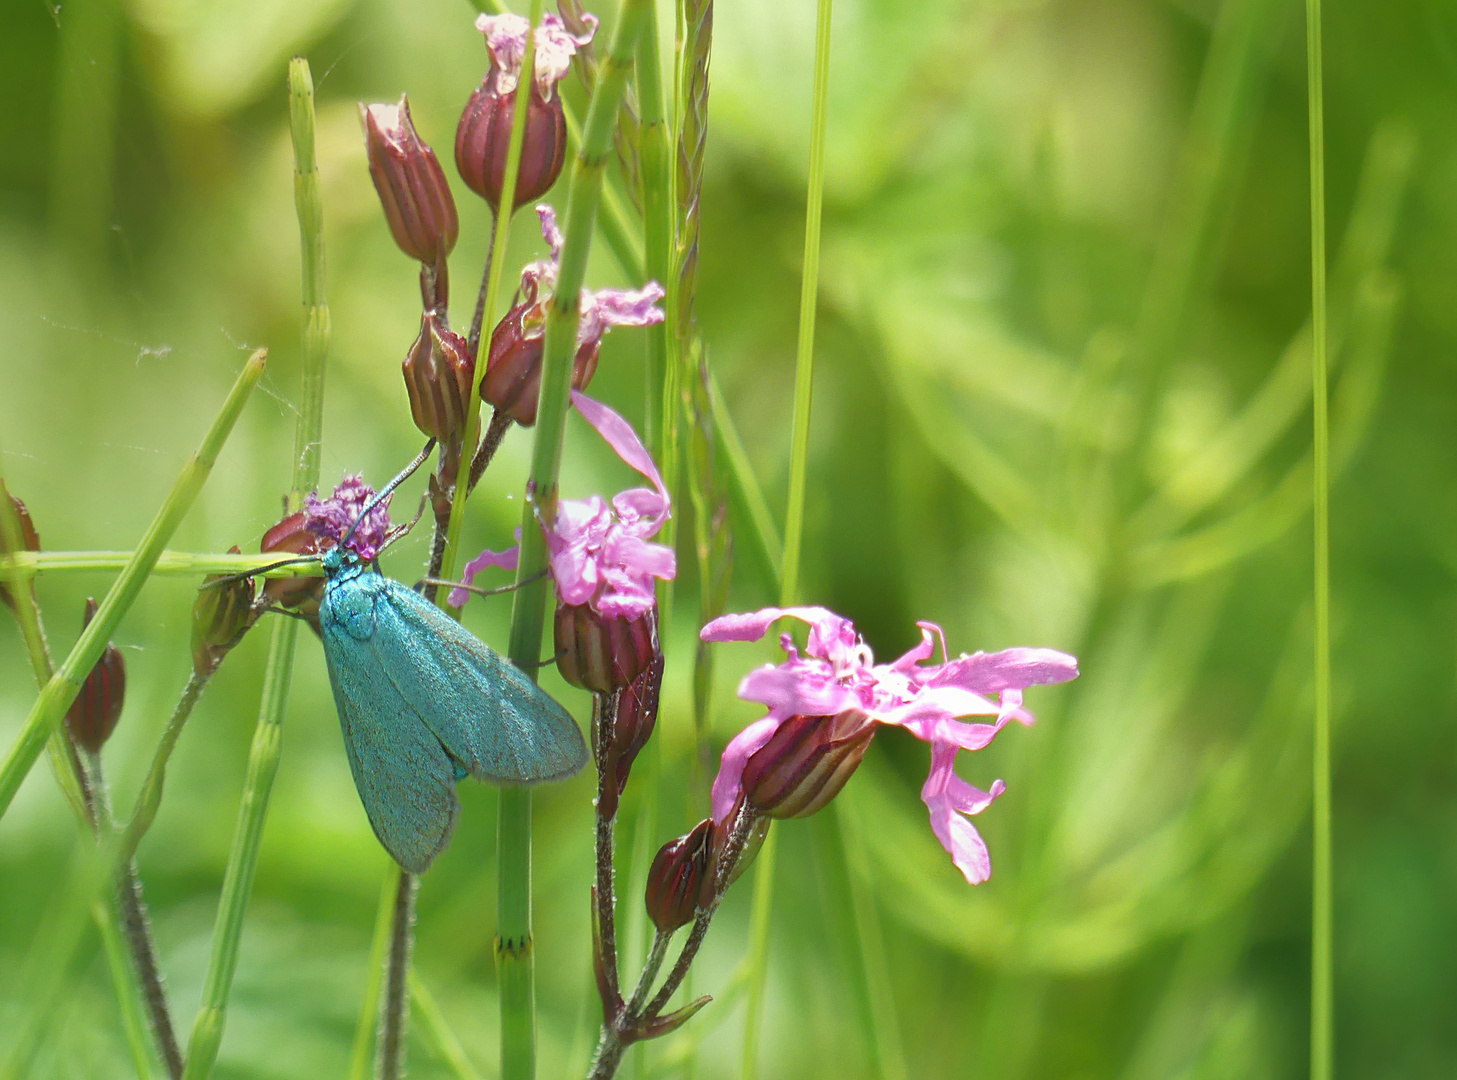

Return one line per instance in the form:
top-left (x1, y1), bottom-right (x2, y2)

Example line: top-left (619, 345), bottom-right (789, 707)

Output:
top-left (743, 0), bottom-right (832, 1080)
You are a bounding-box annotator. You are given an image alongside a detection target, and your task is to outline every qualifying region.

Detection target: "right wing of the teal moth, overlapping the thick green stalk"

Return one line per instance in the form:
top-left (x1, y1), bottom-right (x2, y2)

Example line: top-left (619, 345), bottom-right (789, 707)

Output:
top-left (376, 582), bottom-right (587, 784)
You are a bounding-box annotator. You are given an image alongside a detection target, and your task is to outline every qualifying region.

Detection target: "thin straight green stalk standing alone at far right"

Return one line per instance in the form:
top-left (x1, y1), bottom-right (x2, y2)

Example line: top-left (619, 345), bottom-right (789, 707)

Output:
top-left (1305, 0), bottom-right (1335, 1080)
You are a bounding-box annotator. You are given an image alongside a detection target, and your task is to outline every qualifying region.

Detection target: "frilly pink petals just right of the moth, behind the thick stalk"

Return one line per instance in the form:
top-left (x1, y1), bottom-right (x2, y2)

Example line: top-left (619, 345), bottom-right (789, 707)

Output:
top-left (450, 391), bottom-right (678, 619)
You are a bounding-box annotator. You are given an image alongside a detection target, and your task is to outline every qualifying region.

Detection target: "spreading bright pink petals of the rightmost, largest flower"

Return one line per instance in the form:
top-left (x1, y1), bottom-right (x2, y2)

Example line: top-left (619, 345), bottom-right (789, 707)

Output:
top-left (699, 608), bottom-right (1078, 885)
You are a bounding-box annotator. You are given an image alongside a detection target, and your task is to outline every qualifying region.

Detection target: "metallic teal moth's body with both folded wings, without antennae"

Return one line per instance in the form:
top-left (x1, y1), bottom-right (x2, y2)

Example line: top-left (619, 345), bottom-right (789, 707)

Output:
top-left (319, 558), bottom-right (587, 873)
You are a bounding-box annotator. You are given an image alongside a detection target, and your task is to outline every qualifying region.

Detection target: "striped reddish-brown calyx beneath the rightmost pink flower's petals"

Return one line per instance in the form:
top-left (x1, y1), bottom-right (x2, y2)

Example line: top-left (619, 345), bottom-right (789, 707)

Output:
top-left (743, 708), bottom-right (876, 818)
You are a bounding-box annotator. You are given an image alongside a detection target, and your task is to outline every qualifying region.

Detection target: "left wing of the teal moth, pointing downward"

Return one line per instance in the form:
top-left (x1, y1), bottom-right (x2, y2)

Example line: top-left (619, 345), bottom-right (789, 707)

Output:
top-left (322, 603), bottom-right (460, 873)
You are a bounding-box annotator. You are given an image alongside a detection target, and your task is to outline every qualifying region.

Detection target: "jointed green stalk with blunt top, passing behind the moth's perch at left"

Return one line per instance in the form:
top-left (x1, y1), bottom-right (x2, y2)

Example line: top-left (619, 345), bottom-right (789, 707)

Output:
top-left (184, 57), bottom-right (329, 1080)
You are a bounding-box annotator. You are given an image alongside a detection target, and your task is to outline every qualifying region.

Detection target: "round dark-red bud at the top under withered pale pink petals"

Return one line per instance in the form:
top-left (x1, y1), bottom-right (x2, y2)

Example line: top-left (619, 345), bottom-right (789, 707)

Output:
top-left (456, 78), bottom-right (567, 213)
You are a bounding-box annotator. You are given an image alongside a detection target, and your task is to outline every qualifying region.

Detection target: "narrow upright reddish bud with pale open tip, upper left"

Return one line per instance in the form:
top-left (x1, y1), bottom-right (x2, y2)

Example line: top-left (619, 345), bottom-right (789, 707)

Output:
top-left (360, 95), bottom-right (460, 267)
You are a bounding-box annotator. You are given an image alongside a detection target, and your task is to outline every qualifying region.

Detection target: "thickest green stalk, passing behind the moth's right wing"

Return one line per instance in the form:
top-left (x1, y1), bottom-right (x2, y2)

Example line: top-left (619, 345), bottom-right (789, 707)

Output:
top-left (495, 0), bottom-right (650, 1080)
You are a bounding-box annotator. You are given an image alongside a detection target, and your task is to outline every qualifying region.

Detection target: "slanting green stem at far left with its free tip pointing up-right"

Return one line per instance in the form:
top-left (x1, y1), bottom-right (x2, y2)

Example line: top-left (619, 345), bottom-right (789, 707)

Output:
top-left (0, 350), bottom-right (268, 816)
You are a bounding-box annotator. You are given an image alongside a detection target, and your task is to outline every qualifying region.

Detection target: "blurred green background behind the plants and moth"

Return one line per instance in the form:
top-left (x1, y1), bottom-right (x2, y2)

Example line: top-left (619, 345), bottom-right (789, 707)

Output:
top-left (0, 0), bottom-right (1457, 1080)
